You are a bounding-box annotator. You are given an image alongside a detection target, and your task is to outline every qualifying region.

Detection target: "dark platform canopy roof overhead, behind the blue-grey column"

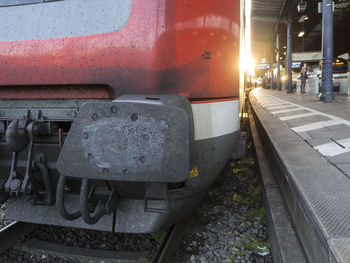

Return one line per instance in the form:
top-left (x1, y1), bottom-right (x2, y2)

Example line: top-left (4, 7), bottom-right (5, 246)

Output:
top-left (251, 0), bottom-right (350, 63)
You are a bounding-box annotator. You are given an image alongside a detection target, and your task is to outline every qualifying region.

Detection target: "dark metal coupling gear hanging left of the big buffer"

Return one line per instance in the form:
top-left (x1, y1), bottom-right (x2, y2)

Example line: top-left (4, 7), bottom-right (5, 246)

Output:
top-left (2, 118), bottom-right (55, 205)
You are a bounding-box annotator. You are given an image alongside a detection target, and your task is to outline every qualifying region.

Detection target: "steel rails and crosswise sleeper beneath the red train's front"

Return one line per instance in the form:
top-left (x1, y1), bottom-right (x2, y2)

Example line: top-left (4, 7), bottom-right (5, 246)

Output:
top-left (0, 221), bottom-right (183, 263)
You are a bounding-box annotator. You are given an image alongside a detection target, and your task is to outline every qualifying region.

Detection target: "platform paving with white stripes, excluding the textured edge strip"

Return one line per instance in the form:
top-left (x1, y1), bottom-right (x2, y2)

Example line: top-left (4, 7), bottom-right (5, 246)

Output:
top-left (255, 89), bottom-right (350, 179)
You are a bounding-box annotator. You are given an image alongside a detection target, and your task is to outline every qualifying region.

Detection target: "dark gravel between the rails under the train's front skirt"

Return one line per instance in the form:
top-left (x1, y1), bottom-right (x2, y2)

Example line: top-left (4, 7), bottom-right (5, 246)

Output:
top-left (0, 226), bottom-right (159, 263)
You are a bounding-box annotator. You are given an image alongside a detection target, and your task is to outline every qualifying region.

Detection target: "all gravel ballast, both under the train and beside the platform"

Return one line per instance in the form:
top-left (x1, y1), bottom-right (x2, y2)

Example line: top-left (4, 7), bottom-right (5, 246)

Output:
top-left (0, 118), bottom-right (272, 263)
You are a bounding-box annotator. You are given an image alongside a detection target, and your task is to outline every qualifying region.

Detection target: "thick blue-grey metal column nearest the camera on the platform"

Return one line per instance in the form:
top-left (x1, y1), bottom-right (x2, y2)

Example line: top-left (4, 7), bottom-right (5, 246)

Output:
top-left (320, 0), bottom-right (333, 102)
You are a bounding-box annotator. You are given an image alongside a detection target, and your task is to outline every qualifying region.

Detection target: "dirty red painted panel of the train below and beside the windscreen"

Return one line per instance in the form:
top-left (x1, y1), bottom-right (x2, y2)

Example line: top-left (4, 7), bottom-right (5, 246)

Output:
top-left (0, 0), bottom-right (240, 98)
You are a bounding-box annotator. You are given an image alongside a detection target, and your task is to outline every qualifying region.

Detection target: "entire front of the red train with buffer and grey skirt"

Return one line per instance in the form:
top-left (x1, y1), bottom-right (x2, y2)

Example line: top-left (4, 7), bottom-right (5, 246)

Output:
top-left (0, 0), bottom-right (240, 233)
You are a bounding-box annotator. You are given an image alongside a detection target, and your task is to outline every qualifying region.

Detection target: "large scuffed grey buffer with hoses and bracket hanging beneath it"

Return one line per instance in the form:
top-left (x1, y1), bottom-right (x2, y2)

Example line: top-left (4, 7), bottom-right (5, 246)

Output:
top-left (56, 94), bottom-right (193, 224)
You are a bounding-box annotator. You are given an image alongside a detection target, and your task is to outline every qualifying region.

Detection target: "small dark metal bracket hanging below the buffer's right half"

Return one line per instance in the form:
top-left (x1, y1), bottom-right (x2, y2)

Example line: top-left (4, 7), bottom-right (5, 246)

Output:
top-left (144, 183), bottom-right (170, 214)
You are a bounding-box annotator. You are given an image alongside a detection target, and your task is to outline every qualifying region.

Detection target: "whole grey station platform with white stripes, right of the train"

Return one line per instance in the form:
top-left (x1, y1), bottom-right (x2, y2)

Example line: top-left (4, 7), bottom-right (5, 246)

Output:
top-left (250, 89), bottom-right (350, 263)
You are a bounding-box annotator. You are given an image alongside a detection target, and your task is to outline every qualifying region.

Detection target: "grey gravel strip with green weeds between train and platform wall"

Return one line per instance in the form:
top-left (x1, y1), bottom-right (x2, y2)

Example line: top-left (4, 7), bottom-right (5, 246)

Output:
top-left (173, 120), bottom-right (272, 263)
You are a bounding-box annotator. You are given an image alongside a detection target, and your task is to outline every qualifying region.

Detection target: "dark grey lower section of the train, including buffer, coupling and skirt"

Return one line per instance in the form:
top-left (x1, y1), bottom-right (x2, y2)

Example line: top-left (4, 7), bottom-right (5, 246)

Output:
top-left (0, 94), bottom-right (238, 233)
